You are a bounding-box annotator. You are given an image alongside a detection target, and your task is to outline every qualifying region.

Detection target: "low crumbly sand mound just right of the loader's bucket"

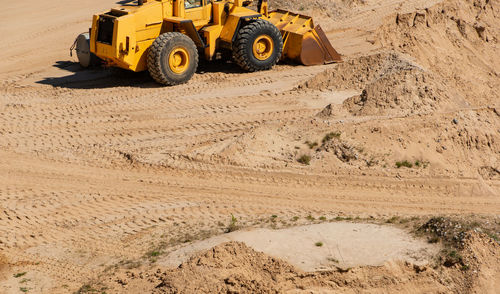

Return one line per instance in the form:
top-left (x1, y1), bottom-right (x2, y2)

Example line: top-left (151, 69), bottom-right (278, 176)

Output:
top-left (298, 53), bottom-right (456, 115)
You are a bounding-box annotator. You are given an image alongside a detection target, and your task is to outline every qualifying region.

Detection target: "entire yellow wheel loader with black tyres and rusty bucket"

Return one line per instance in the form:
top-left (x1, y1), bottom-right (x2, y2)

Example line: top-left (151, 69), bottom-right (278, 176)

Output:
top-left (73, 0), bottom-right (341, 85)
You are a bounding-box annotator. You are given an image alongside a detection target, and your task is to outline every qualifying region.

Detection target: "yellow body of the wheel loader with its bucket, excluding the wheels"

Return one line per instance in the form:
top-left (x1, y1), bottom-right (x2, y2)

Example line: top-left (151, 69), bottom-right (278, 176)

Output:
top-left (89, 0), bottom-right (341, 71)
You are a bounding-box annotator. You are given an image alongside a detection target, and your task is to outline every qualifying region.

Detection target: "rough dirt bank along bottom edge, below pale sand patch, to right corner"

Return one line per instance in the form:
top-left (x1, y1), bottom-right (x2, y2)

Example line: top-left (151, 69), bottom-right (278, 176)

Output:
top-left (96, 232), bottom-right (500, 293)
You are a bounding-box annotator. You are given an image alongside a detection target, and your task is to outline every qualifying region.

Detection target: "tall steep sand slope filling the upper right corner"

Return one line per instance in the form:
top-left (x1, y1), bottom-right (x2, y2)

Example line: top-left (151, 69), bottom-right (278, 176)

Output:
top-left (378, 0), bottom-right (500, 105)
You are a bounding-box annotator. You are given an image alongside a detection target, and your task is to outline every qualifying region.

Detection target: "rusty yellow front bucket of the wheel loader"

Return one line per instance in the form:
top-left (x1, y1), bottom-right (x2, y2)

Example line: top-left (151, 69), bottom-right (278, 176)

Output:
top-left (267, 9), bottom-right (342, 65)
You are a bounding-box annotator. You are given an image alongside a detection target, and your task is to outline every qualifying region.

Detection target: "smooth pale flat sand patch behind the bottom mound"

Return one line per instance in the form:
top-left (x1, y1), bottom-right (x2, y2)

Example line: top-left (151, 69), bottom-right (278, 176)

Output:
top-left (160, 222), bottom-right (438, 271)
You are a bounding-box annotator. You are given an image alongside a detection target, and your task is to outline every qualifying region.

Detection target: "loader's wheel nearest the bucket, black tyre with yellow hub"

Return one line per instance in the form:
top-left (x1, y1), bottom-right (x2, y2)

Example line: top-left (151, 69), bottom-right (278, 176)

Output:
top-left (233, 19), bottom-right (283, 71)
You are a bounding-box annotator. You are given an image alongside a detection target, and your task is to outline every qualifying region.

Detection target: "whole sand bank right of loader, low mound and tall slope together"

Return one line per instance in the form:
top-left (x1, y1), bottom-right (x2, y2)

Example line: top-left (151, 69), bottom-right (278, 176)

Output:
top-left (299, 0), bottom-right (500, 115)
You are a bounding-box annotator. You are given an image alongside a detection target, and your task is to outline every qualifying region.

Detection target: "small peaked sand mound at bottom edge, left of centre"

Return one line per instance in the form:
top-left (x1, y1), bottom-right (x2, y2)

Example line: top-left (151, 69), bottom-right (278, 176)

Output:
top-left (156, 242), bottom-right (298, 293)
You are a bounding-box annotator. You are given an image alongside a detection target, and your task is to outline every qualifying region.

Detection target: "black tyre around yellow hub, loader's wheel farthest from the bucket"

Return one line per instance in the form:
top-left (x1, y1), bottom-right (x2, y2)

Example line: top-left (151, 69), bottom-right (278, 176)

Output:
top-left (148, 32), bottom-right (199, 86)
